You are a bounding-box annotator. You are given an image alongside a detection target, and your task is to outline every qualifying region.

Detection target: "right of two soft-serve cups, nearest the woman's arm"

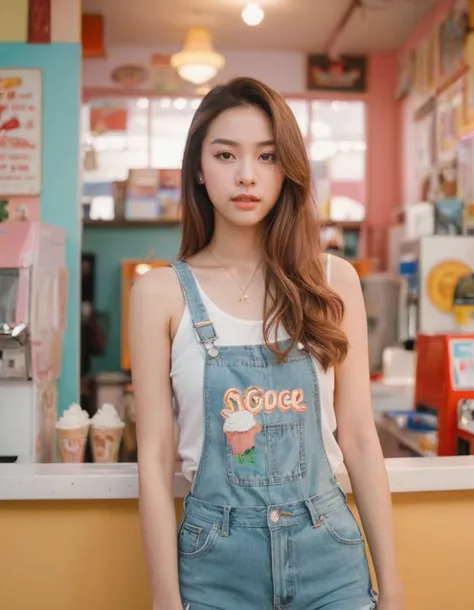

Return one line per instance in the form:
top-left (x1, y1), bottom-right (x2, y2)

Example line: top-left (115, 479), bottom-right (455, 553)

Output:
top-left (91, 402), bottom-right (125, 463)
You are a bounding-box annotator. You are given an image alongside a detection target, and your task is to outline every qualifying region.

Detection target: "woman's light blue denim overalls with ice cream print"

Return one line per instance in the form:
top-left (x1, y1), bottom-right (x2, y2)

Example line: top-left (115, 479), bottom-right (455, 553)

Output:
top-left (173, 261), bottom-right (376, 610)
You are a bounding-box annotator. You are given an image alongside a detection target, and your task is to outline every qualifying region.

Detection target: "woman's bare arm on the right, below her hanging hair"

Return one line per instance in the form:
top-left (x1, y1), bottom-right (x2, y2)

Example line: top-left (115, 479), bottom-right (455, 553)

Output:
top-left (331, 257), bottom-right (402, 610)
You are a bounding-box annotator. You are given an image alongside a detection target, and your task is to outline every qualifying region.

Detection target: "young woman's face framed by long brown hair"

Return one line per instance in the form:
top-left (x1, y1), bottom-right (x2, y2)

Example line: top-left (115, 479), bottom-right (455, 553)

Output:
top-left (201, 106), bottom-right (284, 226)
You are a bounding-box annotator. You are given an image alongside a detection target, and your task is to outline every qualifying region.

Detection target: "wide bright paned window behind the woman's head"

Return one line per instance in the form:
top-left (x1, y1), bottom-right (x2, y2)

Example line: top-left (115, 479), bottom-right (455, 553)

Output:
top-left (82, 97), bottom-right (366, 220)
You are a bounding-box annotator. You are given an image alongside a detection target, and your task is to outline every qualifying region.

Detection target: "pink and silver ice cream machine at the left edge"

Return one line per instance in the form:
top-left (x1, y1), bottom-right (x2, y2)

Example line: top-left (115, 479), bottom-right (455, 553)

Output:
top-left (0, 221), bottom-right (67, 463)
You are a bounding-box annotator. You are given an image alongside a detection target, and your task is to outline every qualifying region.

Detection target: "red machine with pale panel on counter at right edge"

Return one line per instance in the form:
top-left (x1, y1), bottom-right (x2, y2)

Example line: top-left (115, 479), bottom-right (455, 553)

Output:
top-left (415, 333), bottom-right (474, 456)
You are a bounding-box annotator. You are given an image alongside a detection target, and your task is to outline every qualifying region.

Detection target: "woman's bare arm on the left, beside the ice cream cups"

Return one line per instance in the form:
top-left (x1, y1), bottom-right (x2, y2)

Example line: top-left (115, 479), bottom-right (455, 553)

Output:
top-left (129, 268), bottom-right (182, 610)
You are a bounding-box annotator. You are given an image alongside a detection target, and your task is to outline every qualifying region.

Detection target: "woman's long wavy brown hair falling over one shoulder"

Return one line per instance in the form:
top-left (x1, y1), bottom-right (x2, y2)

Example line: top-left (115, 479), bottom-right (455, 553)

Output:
top-left (179, 77), bottom-right (348, 369)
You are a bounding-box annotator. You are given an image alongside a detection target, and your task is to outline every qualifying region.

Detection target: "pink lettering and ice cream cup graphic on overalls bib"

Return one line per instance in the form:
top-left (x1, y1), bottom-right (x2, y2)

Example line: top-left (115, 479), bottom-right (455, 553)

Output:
top-left (221, 386), bottom-right (308, 464)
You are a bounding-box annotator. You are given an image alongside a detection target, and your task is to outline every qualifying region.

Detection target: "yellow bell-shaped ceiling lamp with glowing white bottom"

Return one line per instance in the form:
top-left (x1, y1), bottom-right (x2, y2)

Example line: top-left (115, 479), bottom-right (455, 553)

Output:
top-left (171, 28), bottom-right (225, 85)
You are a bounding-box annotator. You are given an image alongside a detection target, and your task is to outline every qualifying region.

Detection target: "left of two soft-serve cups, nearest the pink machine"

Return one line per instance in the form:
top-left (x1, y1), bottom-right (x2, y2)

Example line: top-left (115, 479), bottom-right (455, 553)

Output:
top-left (56, 403), bottom-right (91, 463)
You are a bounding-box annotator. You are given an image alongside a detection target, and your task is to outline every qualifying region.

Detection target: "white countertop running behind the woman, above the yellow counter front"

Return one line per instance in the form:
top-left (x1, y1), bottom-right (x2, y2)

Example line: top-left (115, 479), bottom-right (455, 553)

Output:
top-left (0, 456), bottom-right (474, 500)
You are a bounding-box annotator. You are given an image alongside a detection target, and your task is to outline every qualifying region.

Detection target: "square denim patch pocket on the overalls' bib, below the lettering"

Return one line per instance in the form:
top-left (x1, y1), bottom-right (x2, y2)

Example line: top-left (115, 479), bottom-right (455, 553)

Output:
top-left (226, 420), bottom-right (306, 487)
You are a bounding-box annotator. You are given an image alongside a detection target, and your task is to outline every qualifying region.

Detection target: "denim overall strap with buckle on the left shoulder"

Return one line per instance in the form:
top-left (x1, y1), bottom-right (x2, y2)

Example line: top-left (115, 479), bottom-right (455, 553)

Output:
top-left (171, 260), bottom-right (219, 358)
